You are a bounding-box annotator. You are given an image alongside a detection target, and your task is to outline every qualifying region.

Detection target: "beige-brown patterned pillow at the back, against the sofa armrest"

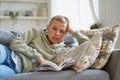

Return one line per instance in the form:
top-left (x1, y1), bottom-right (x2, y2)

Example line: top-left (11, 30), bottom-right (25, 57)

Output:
top-left (80, 25), bottom-right (120, 69)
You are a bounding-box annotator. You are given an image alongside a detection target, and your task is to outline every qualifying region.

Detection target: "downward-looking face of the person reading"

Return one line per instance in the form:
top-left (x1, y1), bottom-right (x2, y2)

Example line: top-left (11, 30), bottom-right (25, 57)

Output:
top-left (47, 20), bottom-right (67, 44)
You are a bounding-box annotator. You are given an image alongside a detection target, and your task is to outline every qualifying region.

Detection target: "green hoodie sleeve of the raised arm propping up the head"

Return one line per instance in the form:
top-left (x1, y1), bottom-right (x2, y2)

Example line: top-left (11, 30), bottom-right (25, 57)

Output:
top-left (73, 31), bottom-right (89, 44)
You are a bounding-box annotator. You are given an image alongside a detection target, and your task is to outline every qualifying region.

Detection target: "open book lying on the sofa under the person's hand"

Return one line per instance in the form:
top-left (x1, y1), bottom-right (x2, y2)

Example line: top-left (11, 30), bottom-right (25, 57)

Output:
top-left (36, 58), bottom-right (75, 71)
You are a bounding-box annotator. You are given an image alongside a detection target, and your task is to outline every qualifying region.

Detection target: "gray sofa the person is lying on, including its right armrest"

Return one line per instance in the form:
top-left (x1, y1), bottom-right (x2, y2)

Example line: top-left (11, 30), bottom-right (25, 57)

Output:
top-left (0, 31), bottom-right (120, 80)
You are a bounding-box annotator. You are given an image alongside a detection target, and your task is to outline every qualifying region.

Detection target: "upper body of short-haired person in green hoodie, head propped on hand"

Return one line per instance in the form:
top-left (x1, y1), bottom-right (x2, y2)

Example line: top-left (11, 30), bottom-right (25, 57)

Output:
top-left (0, 15), bottom-right (88, 77)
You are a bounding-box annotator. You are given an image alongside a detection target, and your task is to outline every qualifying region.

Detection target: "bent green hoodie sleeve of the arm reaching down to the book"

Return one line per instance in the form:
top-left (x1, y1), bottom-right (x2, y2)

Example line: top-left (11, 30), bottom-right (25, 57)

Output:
top-left (10, 29), bottom-right (41, 59)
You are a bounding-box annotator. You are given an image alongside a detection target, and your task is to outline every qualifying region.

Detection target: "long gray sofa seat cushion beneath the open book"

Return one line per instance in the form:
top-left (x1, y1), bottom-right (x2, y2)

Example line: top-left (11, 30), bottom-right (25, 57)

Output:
top-left (0, 69), bottom-right (110, 80)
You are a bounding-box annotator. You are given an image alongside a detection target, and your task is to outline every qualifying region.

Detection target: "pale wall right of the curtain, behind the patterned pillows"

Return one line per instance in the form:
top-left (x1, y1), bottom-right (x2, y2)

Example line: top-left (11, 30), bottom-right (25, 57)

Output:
top-left (99, 0), bottom-right (120, 48)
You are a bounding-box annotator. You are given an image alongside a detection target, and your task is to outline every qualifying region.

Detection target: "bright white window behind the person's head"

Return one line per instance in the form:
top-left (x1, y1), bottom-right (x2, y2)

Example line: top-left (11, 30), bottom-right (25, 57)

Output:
top-left (51, 0), bottom-right (93, 30)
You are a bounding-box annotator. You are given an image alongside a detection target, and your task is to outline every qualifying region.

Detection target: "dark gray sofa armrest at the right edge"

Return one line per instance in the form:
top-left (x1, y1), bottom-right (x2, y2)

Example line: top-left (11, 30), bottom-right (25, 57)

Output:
top-left (103, 49), bottom-right (120, 80)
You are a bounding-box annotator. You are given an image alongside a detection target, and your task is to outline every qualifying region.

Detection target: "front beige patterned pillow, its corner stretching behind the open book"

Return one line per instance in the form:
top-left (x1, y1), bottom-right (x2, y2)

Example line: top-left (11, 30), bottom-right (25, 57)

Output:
top-left (53, 32), bottom-right (103, 72)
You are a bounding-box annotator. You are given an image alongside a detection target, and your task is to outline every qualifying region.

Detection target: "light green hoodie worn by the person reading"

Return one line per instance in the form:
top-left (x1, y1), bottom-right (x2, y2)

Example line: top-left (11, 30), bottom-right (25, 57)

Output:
top-left (10, 28), bottom-right (88, 72)
